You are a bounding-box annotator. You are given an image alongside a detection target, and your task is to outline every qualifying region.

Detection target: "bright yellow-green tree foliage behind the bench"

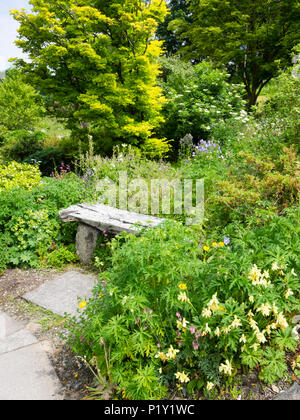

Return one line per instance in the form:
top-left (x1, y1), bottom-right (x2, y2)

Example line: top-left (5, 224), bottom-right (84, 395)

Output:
top-left (12, 0), bottom-right (167, 151)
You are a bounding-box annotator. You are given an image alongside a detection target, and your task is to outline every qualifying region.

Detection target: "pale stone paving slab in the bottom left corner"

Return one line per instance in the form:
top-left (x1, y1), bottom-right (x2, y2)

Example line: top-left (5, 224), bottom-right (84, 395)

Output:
top-left (0, 343), bottom-right (63, 401)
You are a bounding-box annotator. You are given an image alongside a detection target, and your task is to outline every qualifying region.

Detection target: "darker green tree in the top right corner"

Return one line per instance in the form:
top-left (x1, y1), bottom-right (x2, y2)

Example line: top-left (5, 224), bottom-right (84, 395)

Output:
top-left (169, 0), bottom-right (300, 106)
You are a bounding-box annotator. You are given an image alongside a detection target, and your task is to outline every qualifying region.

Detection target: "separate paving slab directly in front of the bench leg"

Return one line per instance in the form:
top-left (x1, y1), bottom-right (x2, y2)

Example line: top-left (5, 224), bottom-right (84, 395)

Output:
top-left (23, 271), bottom-right (97, 316)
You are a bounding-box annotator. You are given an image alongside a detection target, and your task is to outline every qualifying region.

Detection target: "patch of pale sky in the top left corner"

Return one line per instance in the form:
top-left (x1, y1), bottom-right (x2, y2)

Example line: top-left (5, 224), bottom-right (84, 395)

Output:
top-left (0, 0), bottom-right (29, 71)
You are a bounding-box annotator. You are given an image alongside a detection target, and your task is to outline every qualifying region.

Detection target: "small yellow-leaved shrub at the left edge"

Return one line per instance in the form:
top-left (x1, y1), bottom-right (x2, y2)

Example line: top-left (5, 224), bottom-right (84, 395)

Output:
top-left (0, 162), bottom-right (41, 192)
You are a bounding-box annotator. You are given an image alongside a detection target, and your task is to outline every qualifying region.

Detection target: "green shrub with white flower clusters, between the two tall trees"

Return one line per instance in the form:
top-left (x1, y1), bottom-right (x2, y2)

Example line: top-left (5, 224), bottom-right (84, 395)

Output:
top-left (160, 57), bottom-right (246, 149)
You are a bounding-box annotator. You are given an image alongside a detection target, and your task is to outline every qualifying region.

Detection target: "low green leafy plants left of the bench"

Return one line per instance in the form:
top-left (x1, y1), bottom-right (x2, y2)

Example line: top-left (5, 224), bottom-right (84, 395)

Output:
top-left (0, 172), bottom-right (85, 269)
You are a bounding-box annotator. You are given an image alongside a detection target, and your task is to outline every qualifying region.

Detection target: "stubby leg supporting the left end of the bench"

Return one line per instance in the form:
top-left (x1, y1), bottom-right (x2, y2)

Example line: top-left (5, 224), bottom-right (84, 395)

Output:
top-left (76, 223), bottom-right (99, 264)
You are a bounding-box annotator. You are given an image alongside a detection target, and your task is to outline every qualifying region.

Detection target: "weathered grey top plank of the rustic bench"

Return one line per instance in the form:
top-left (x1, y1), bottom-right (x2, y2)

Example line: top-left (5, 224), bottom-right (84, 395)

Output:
top-left (59, 203), bottom-right (164, 234)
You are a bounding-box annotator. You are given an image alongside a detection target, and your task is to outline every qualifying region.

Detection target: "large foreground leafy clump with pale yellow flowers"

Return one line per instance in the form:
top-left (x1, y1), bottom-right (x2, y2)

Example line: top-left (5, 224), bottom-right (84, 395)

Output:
top-left (65, 209), bottom-right (300, 399)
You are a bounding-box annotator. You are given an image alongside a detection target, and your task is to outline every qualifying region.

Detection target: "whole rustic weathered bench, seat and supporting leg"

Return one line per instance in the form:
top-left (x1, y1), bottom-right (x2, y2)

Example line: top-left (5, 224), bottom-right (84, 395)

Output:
top-left (59, 203), bottom-right (164, 264)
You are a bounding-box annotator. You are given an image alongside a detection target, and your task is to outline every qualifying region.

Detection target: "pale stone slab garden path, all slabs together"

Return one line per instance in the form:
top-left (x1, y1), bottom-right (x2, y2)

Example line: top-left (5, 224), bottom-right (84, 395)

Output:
top-left (0, 271), bottom-right (96, 400)
